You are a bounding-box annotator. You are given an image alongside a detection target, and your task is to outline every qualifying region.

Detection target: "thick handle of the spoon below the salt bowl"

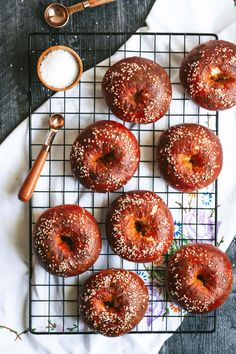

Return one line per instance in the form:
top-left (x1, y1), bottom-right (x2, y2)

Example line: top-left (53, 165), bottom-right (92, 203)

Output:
top-left (18, 145), bottom-right (49, 203)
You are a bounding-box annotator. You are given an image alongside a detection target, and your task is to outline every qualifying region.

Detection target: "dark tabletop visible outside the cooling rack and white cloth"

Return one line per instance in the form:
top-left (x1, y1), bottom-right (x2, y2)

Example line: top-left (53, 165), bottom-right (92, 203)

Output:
top-left (0, 0), bottom-right (236, 354)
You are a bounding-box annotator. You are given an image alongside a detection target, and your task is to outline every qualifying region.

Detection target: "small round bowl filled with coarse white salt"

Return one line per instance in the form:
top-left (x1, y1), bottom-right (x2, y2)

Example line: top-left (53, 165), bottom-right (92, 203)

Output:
top-left (37, 45), bottom-right (83, 91)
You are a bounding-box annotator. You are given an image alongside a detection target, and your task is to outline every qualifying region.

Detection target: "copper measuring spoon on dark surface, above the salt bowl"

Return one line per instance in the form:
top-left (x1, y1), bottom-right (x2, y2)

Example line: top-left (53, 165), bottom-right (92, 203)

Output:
top-left (44, 0), bottom-right (116, 28)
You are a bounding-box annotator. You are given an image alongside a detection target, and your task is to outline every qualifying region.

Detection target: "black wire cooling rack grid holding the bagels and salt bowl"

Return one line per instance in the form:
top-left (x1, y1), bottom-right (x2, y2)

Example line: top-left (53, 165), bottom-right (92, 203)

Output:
top-left (29, 33), bottom-right (218, 334)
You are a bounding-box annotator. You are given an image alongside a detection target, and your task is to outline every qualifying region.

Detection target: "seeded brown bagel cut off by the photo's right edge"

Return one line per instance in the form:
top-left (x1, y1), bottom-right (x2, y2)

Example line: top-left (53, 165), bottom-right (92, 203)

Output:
top-left (180, 40), bottom-right (236, 111)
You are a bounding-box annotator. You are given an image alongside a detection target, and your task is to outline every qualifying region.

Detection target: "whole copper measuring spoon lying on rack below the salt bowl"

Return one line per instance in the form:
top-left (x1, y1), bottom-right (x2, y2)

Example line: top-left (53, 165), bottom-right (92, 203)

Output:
top-left (18, 114), bottom-right (64, 203)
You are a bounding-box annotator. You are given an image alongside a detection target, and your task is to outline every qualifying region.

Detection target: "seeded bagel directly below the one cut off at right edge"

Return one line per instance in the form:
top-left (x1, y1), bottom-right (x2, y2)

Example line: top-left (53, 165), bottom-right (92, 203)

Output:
top-left (157, 123), bottom-right (223, 192)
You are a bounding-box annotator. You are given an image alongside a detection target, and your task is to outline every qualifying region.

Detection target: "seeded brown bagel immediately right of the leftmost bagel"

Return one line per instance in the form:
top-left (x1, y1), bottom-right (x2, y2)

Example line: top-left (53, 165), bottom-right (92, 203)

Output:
top-left (106, 191), bottom-right (174, 262)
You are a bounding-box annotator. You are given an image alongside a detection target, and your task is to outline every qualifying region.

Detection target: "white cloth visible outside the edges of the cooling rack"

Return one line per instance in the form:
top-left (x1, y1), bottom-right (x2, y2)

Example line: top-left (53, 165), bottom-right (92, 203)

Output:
top-left (0, 0), bottom-right (236, 354)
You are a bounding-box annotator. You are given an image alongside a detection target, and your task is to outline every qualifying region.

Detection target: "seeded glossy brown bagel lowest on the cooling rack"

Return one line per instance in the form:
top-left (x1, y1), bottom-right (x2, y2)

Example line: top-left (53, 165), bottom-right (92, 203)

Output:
top-left (80, 269), bottom-right (148, 337)
